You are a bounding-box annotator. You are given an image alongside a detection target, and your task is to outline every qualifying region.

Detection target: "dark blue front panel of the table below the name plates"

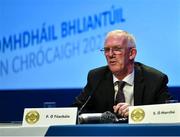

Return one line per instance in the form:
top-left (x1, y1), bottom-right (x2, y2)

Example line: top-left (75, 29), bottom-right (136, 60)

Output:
top-left (45, 123), bottom-right (180, 136)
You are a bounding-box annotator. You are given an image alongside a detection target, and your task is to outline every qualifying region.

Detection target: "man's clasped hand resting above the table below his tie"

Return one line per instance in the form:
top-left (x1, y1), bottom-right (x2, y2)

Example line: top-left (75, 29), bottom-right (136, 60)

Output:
top-left (113, 103), bottom-right (129, 117)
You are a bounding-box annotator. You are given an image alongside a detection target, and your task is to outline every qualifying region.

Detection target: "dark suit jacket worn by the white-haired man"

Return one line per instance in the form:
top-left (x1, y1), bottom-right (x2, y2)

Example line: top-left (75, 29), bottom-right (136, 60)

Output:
top-left (74, 62), bottom-right (170, 113)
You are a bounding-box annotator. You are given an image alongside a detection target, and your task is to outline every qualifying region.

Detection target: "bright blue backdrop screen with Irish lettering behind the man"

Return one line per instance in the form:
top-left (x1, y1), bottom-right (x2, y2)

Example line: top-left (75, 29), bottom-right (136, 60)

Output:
top-left (0, 0), bottom-right (180, 90)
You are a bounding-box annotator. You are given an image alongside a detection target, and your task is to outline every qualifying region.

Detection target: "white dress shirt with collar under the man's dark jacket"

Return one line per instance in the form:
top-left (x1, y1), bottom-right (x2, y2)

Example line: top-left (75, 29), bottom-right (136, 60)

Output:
top-left (113, 70), bottom-right (134, 106)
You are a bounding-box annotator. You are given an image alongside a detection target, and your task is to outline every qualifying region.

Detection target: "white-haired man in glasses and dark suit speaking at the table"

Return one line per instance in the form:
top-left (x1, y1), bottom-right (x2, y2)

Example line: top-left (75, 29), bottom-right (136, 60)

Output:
top-left (74, 30), bottom-right (170, 117)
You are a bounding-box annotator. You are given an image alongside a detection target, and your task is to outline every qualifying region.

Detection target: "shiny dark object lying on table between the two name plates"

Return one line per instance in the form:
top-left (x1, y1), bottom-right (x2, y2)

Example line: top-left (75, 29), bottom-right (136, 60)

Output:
top-left (78, 111), bottom-right (128, 124)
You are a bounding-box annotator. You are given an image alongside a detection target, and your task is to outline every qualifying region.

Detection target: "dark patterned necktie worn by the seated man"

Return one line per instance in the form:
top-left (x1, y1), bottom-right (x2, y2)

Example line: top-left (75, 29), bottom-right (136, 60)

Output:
top-left (115, 81), bottom-right (125, 104)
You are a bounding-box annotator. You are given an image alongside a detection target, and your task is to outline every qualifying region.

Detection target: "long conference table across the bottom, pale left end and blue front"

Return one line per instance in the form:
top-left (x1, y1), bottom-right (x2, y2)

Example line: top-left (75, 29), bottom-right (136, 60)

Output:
top-left (0, 123), bottom-right (180, 136)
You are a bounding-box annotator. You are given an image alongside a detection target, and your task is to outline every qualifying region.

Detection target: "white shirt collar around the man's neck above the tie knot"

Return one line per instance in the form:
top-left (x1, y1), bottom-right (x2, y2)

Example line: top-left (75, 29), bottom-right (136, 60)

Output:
top-left (113, 69), bottom-right (134, 86)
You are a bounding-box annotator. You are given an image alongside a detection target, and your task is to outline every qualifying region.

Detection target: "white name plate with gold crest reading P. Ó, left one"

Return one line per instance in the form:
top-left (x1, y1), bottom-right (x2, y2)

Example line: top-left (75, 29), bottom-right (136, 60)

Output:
top-left (22, 107), bottom-right (77, 126)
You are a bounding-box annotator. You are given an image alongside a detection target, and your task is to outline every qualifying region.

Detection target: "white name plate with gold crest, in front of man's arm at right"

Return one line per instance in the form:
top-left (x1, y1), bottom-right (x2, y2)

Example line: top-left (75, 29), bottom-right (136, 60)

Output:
top-left (129, 103), bottom-right (180, 124)
